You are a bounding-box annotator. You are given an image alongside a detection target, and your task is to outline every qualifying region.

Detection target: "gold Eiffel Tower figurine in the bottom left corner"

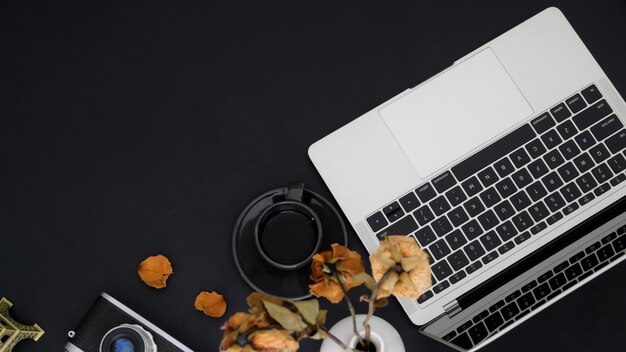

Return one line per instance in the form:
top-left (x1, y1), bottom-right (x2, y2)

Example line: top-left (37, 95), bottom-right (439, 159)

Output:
top-left (0, 298), bottom-right (45, 352)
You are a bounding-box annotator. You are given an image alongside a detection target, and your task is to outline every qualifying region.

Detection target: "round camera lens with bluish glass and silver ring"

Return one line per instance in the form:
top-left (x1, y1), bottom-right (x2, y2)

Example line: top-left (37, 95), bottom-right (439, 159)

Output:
top-left (100, 324), bottom-right (157, 352)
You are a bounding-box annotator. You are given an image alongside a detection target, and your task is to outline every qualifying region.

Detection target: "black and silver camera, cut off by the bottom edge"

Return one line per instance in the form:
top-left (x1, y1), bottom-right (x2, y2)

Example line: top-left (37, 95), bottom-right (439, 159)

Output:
top-left (65, 293), bottom-right (193, 352)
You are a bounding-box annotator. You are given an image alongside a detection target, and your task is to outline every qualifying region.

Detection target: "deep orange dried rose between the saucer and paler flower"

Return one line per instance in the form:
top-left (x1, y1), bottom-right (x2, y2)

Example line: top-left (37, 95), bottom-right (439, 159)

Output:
top-left (309, 243), bottom-right (365, 303)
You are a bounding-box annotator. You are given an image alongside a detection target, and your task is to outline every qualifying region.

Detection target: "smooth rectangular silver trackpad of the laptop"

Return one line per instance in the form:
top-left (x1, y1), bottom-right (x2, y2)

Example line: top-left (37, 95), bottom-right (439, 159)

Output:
top-left (380, 49), bottom-right (533, 178)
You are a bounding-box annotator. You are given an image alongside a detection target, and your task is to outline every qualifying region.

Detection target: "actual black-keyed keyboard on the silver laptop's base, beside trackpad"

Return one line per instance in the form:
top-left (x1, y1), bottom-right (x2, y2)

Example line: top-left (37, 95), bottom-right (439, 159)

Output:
top-left (366, 85), bottom-right (626, 304)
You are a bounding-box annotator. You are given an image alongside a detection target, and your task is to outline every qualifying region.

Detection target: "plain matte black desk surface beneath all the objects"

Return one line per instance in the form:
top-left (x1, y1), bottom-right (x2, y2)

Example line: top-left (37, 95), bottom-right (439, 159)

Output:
top-left (0, 0), bottom-right (626, 352)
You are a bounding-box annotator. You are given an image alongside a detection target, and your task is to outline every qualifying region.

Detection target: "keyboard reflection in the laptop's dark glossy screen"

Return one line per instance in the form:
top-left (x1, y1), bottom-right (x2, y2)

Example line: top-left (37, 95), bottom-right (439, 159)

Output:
top-left (443, 226), bottom-right (626, 349)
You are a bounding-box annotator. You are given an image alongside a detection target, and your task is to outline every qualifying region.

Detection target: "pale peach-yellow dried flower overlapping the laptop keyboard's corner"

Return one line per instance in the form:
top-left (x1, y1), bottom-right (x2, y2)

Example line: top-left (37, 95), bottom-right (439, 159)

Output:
top-left (370, 236), bottom-right (432, 299)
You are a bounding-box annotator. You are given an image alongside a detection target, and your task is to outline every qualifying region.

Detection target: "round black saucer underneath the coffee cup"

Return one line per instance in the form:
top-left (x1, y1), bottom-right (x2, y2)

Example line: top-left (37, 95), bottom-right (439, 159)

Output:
top-left (233, 187), bottom-right (348, 300)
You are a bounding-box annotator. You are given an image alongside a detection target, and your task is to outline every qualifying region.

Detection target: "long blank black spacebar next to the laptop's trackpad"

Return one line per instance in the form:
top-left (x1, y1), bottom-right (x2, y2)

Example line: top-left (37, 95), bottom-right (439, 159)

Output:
top-left (452, 124), bottom-right (536, 181)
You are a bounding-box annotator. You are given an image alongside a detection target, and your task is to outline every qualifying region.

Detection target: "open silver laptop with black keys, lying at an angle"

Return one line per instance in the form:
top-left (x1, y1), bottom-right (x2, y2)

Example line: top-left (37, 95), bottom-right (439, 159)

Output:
top-left (309, 8), bottom-right (626, 351)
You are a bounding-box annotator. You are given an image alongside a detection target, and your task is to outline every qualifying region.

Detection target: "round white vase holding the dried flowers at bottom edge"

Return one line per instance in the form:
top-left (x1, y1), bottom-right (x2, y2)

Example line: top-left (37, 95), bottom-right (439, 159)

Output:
top-left (320, 314), bottom-right (405, 352)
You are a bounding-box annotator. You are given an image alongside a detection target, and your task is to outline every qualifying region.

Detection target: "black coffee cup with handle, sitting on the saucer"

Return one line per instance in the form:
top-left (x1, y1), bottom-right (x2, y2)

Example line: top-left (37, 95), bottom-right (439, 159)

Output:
top-left (254, 183), bottom-right (322, 270)
